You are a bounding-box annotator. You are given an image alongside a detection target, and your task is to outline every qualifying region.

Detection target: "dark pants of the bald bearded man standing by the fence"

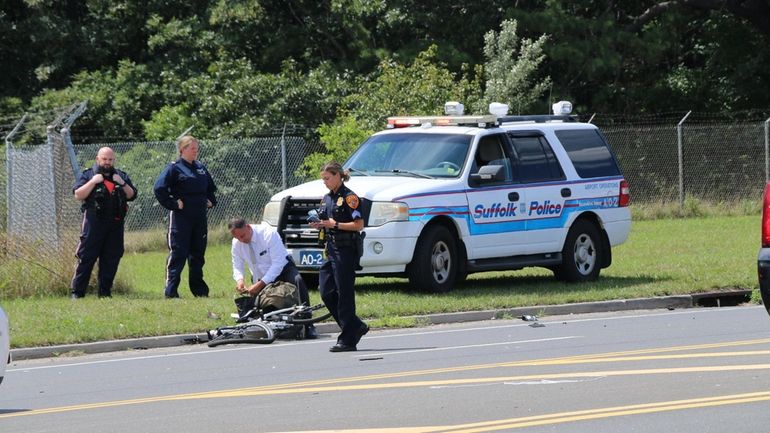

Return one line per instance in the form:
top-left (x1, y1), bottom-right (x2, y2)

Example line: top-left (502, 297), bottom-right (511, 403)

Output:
top-left (70, 211), bottom-right (124, 297)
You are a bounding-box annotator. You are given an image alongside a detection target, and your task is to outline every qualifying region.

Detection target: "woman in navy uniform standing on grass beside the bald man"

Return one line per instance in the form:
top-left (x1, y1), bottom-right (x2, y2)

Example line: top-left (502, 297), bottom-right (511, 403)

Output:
top-left (154, 135), bottom-right (217, 298)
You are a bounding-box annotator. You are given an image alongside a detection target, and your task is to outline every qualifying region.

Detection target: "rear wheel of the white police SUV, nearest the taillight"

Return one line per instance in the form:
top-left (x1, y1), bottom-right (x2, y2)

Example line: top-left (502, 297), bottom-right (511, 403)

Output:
top-left (553, 220), bottom-right (604, 282)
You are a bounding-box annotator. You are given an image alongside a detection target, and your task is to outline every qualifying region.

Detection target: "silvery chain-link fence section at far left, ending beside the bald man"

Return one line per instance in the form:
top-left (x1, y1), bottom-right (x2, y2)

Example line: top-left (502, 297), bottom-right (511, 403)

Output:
top-left (0, 111), bottom-right (85, 297)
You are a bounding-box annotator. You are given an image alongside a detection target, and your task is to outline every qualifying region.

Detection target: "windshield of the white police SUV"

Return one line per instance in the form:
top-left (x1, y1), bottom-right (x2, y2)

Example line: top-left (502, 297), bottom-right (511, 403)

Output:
top-left (345, 133), bottom-right (472, 178)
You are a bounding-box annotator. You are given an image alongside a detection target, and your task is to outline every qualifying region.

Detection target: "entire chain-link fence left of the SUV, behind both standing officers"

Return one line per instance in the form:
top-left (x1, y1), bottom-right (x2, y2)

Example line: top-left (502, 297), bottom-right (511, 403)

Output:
top-left (0, 114), bottom-right (320, 296)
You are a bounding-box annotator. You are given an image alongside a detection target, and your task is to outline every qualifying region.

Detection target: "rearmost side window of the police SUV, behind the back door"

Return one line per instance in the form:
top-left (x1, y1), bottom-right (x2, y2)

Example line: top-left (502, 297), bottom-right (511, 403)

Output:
top-left (556, 129), bottom-right (620, 178)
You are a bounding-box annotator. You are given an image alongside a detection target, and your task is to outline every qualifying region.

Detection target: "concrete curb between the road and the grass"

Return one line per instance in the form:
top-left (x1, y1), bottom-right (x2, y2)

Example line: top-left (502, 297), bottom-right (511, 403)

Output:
top-left (11, 290), bottom-right (752, 360)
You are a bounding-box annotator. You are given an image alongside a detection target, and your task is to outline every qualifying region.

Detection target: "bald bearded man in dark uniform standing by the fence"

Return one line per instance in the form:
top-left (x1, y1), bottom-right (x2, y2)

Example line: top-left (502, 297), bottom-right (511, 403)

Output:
top-left (70, 147), bottom-right (136, 299)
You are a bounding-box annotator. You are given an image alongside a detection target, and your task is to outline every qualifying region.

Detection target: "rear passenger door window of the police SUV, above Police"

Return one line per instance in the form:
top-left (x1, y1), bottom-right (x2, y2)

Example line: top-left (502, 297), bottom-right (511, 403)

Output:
top-left (509, 132), bottom-right (564, 183)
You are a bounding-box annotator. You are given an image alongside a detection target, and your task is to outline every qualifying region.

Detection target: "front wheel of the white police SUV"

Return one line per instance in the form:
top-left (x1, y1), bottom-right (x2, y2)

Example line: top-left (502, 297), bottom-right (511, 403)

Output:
top-left (407, 225), bottom-right (458, 293)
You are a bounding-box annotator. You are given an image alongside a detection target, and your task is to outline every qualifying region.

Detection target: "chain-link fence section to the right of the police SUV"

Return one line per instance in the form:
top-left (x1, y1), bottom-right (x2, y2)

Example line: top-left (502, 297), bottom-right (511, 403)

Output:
top-left (592, 113), bottom-right (769, 205)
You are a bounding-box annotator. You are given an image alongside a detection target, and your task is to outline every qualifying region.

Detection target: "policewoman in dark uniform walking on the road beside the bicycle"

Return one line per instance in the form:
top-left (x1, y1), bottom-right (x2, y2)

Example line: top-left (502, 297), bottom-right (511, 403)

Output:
top-left (310, 162), bottom-right (369, 352)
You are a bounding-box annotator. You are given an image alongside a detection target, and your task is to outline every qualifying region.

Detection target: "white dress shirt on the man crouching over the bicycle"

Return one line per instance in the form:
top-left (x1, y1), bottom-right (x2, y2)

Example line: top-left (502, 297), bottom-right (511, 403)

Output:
top-left (230, 224), bottom-right (289, 284)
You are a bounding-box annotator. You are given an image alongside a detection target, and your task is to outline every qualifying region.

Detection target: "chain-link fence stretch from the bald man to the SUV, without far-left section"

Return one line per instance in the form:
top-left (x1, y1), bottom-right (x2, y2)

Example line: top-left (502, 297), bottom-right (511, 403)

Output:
top-left (68, 135), bottom-right (319, 235)
